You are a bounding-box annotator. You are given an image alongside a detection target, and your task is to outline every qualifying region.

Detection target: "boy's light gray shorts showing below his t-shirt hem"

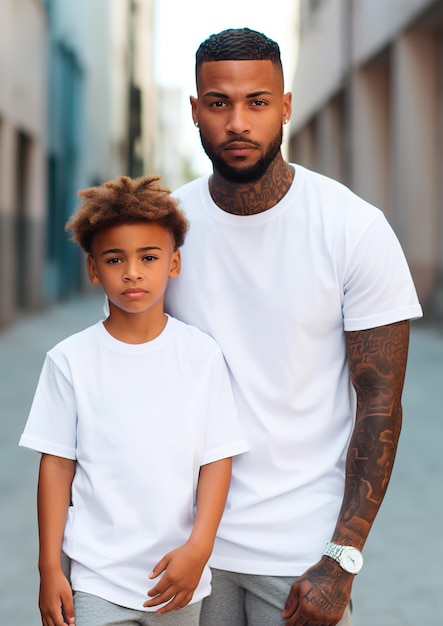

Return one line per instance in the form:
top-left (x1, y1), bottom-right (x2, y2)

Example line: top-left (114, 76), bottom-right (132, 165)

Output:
top-left (74, 591), bottom-right (202, 626)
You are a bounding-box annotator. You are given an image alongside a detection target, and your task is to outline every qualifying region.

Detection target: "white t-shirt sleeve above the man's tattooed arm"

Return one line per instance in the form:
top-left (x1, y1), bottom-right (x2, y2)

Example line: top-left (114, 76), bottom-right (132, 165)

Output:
top-left (343, 213), bottom-right (423, 331)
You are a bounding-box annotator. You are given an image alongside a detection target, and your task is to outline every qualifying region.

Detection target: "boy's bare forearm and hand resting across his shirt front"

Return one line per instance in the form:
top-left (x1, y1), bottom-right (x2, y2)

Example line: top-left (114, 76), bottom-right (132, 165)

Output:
top-left (144, 458), bottom-right (232, 614)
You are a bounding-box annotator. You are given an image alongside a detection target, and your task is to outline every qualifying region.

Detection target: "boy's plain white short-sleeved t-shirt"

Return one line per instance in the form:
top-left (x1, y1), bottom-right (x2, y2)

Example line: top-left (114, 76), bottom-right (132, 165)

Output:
top-left (20, 318), bottom-right (247, 610)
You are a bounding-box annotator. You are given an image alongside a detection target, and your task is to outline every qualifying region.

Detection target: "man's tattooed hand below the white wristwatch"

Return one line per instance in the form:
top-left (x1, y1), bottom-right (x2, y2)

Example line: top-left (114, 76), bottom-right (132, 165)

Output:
top-left (282, 557), bottom-right (354, 626)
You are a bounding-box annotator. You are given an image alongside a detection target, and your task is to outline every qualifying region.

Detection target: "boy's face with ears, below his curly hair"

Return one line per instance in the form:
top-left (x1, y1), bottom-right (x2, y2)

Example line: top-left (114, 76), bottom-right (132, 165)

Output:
top-left (87, 222), bottom-right (180, 315)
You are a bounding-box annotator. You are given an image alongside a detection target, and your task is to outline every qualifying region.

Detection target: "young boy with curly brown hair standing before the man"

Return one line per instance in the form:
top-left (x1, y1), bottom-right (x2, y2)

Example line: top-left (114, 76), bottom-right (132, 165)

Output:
top-left (20, 176), bottom-right (247, 626)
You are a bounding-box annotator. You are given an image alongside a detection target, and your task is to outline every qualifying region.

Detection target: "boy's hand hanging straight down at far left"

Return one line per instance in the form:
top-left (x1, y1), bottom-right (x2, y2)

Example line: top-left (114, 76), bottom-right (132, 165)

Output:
top-left (39, 570), bottom-right (74, 626)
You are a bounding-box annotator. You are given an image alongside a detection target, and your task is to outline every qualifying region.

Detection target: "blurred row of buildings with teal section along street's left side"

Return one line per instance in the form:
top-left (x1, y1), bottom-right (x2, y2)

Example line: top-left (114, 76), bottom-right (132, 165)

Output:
top-left (0, 0), bottom-right (157, 326)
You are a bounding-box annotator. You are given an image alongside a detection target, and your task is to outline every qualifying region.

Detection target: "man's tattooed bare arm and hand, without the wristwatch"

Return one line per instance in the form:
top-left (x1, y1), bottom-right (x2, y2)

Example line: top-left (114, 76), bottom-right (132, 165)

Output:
top-left (283, 321), bottom-right (409, 626)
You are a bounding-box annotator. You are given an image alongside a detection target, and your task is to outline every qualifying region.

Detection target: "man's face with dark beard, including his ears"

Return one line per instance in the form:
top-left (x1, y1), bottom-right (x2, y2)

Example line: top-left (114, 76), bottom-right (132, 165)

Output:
top-left (191, 61), bottom-right (291, 183)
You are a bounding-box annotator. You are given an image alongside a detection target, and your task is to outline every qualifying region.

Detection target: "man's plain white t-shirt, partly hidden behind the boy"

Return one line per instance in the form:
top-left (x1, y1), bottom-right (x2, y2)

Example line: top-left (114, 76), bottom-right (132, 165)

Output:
top-left (167, 165), bottom-right (422, 576)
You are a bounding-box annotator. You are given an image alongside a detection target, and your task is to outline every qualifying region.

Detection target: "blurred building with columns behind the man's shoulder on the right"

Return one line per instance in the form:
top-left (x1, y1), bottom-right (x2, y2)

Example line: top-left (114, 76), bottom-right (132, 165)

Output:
top-left (290, 0), bottom-right (443, 314)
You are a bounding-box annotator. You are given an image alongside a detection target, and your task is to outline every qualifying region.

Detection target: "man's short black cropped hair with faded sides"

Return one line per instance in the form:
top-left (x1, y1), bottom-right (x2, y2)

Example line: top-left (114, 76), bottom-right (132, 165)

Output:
top-left (195, 28), bottom-right (283, 76)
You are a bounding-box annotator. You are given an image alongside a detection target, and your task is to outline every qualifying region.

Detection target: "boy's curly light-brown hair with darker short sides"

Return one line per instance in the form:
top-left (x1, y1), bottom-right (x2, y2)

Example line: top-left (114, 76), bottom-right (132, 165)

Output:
top-left (65, 176), bottom-right (189, 254)
